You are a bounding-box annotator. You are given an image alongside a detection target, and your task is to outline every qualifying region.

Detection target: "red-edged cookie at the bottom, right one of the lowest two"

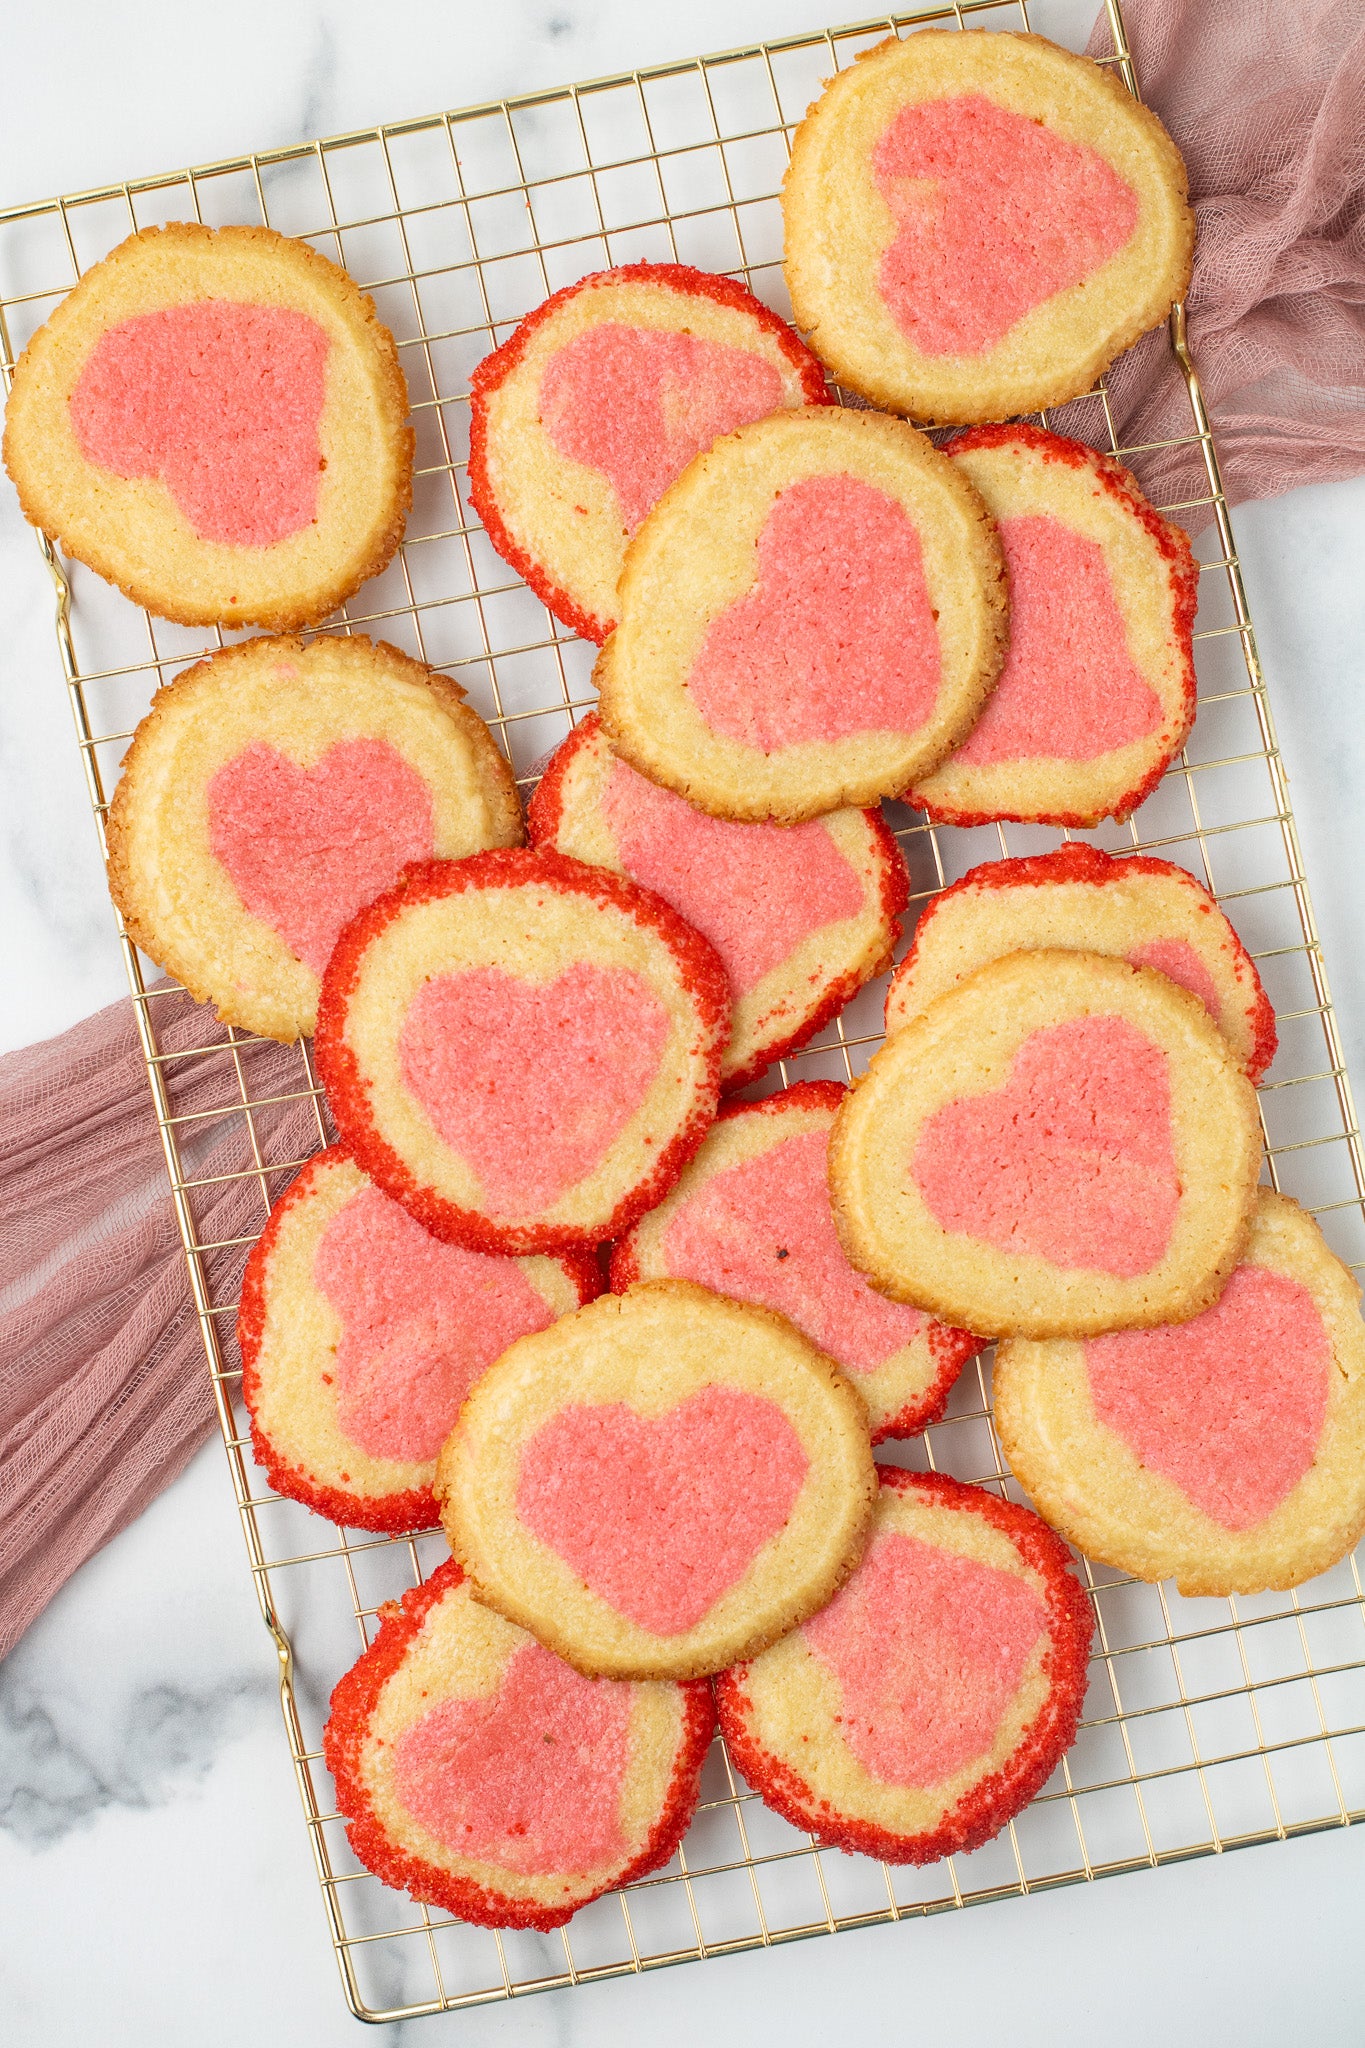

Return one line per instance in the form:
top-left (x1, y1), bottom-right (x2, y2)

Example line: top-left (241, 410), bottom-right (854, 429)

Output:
top-left (716, 1464), bottom-right (1095, 1864)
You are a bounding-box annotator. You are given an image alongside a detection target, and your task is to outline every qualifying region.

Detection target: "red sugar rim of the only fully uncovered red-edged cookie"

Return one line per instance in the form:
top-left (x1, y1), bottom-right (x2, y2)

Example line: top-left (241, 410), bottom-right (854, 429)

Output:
top-left (313, 846), bottom-right (731, 1255)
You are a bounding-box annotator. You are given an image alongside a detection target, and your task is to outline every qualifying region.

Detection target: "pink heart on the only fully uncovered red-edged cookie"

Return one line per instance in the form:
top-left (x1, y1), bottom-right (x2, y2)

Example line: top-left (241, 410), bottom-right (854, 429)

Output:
top-left (399, 965), bottom-right (669, 1217)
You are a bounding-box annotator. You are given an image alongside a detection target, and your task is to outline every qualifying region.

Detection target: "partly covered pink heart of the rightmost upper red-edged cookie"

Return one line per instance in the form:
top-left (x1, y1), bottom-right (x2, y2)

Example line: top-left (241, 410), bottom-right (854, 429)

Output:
top-left (954, 516), bottom-right (1162, 766)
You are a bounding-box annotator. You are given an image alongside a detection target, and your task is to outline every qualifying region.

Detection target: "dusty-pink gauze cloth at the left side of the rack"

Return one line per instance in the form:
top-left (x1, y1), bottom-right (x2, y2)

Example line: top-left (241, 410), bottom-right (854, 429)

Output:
top-left (0, 991), bottom-right (319, 1657)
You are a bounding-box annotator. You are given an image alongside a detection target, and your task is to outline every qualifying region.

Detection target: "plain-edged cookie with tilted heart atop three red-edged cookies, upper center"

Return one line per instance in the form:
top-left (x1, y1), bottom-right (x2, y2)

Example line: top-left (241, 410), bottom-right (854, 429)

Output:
top-left (596, 406), bottom-right (1009, 825)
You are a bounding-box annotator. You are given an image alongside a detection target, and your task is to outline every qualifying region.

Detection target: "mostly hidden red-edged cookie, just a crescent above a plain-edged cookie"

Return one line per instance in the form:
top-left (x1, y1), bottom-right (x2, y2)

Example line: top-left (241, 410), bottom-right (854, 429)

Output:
top-left (886, 842), bottom-right (1275, 1081)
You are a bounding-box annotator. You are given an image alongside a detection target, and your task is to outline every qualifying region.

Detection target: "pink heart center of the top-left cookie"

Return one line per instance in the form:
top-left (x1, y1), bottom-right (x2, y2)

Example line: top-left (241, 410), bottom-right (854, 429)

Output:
top-left (72, 299), bottom-right (329, 547)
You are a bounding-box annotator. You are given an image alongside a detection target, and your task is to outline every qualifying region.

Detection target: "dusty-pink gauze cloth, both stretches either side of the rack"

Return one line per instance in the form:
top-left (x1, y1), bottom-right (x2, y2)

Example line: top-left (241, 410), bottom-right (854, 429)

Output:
top-left (0, 0), bottom-right (1365, 1655)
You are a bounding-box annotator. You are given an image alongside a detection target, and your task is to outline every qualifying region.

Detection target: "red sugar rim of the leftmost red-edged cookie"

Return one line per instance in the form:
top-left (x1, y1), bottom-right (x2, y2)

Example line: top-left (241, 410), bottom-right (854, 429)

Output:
top-left (237, 1145), bottom-right (604, 1536)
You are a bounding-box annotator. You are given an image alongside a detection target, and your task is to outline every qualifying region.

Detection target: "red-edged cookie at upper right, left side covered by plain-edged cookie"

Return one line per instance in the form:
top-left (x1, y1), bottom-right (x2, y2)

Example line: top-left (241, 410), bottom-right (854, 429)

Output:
top-left (907, 426), bottom-right (1199, 825)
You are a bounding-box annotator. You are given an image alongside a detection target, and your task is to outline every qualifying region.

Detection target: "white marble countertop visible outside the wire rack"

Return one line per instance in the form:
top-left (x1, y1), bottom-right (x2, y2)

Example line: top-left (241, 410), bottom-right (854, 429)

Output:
top-left (0, 0), bottom-right (1365, 2048)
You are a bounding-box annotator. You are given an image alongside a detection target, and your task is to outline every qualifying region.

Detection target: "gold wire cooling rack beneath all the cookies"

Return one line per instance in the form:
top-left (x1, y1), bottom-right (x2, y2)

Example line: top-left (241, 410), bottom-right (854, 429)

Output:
top-left (0, 0), bottom-right (1365, 2019)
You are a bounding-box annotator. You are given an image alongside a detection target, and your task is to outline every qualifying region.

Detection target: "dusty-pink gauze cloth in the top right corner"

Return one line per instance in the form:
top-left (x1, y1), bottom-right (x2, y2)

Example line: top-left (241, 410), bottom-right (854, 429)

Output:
top-left (1089, 0), bottom-right (1365, 532)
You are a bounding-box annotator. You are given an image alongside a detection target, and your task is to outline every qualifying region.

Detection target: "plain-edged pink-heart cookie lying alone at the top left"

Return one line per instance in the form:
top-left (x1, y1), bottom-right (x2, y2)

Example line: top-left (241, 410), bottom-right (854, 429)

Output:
top-left (4, 221), bottom-right (413, 631)
